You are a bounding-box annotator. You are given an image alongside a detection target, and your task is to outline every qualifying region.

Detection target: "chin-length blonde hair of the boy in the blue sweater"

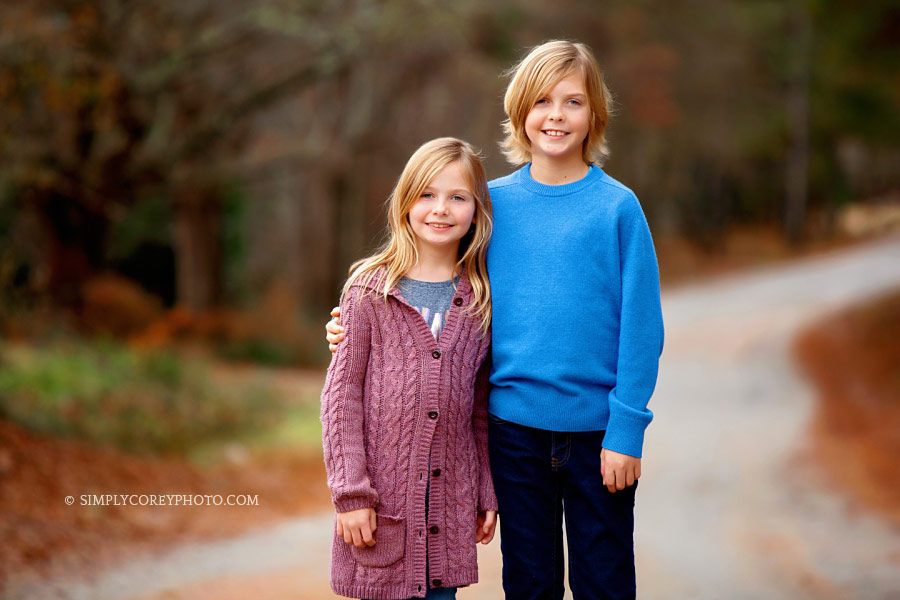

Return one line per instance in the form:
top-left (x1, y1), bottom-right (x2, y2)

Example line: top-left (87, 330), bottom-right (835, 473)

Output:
top-left (500, 40), bottom-right (612, 165)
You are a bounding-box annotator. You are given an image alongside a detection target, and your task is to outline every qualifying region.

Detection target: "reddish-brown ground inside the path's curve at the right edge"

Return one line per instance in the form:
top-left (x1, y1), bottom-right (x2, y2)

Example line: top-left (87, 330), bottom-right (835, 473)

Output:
top-left (795, 292), bottom-right (900, 524)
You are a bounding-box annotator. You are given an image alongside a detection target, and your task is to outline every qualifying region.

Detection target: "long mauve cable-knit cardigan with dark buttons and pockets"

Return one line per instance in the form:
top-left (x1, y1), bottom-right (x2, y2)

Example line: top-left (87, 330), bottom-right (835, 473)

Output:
top-left (321, 272), bottom-right (497, 599)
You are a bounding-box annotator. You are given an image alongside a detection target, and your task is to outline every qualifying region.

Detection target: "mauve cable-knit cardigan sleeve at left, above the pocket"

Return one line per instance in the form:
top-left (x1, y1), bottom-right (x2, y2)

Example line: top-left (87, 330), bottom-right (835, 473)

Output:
top-left (321, 288), bottom-right (378, 512)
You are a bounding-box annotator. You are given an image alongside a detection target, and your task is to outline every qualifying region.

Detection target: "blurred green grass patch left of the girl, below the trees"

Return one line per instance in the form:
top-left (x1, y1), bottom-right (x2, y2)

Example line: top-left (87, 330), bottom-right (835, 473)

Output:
top-left (0, 340), bottom-right (286, 454)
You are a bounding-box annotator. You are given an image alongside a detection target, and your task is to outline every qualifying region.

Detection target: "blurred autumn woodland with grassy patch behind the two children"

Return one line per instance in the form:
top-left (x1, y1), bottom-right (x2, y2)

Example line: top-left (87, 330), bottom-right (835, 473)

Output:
top-left (0, 0), bottom-right (900, 592)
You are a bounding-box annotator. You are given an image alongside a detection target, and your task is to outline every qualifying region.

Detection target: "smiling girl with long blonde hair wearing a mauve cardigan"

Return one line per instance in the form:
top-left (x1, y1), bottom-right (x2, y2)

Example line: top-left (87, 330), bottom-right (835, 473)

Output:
top-left (321, 138), bottom-right (497, 599)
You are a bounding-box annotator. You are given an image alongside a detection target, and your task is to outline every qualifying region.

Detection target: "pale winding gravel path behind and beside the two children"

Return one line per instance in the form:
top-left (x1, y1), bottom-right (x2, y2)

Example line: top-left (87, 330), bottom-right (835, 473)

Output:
top-left (5, 237), bottom-right (900, 600)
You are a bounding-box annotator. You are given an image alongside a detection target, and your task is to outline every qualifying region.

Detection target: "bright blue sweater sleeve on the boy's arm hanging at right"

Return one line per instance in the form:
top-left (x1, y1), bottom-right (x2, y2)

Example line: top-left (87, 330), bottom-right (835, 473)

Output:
top-left (603, 198), bottom-right (663, 457)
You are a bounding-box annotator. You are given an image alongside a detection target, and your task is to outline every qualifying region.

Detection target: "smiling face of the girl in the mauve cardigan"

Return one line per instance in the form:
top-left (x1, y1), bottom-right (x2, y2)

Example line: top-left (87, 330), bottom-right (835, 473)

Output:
top-left (407, 162), bottom-right (475, 255)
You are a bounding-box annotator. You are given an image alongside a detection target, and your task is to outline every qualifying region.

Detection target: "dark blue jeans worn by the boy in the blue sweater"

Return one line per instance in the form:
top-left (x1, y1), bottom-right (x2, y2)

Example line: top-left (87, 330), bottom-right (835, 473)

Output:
top-left (489, 415), bottom-right (637, 600)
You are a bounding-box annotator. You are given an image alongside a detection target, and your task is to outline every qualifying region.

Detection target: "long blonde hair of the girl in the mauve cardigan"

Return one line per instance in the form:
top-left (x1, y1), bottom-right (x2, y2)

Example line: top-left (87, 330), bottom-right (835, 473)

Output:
top-left (341, 137), bottom-right (493, 332)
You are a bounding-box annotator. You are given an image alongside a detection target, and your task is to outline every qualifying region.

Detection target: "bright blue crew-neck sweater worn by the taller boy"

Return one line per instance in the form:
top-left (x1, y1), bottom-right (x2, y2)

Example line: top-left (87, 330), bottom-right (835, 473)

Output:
top-left (487, 164), bottom-right (663, 457)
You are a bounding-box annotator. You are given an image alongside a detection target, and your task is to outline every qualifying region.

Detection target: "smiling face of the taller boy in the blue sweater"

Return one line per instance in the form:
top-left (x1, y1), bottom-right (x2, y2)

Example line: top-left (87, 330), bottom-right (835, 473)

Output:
top-left (525, 73), bottom-right (591, 162)
